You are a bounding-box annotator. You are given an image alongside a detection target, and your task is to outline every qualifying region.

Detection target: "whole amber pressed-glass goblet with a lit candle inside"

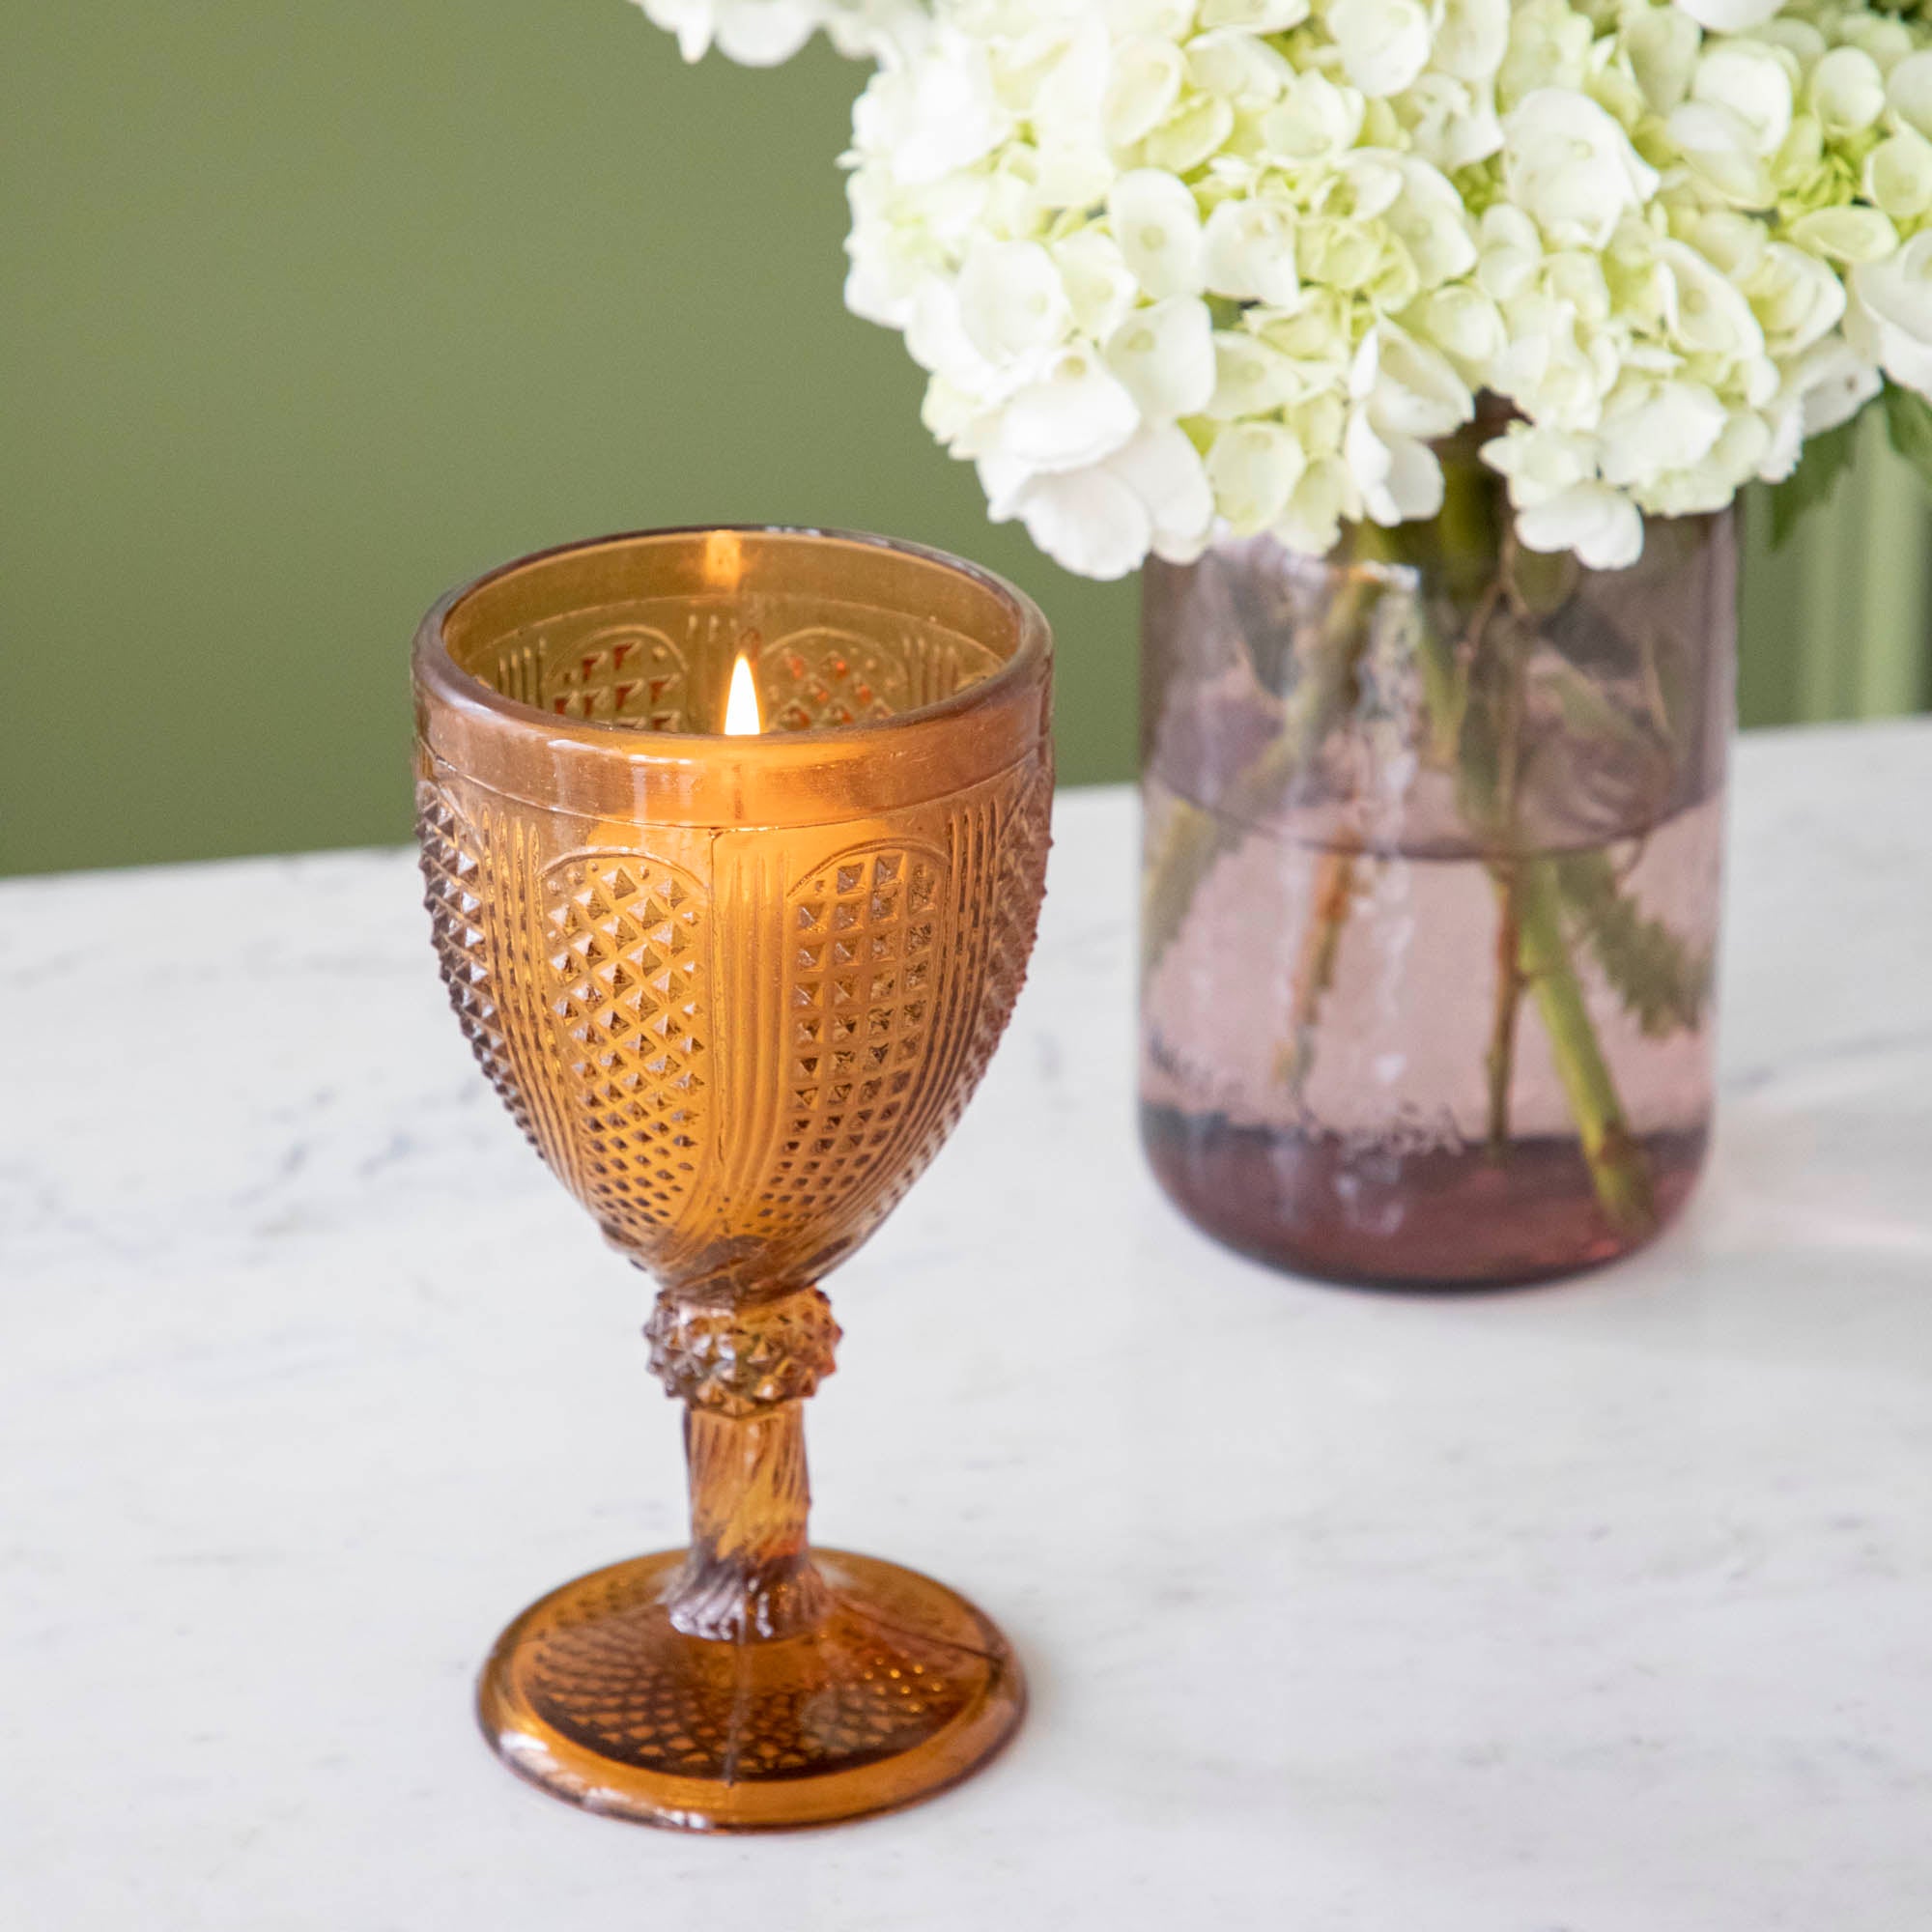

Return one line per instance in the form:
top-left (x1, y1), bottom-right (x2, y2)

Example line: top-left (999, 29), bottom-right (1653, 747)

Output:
top-left (415, 529), bottom-right (1053, 1832)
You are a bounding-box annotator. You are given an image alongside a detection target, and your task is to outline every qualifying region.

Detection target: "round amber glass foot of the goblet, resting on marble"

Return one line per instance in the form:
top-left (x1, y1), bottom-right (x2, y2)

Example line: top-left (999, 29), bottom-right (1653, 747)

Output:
top-left (477, 1549), bottom-right (1026, 1832)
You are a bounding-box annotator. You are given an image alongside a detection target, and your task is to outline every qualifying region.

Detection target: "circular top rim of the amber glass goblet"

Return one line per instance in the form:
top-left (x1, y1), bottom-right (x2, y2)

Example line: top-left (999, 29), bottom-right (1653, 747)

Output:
top-left (412, 524), bottom-right (1053, 761)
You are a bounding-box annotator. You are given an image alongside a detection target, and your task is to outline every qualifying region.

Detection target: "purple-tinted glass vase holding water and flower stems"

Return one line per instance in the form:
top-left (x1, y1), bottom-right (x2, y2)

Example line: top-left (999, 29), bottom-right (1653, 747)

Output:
top-left (1140, 502), bottom-right (1735, 1287)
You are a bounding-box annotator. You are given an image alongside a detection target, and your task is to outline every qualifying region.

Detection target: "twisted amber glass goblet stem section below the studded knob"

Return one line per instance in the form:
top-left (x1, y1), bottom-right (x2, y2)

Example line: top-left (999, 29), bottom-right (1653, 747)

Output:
top-left (667, 1403), bottom-right (829, 1642)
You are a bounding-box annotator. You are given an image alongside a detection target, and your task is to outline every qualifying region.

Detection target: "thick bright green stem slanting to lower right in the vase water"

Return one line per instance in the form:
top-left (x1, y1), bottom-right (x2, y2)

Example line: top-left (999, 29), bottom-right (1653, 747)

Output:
top-left (1517, 860), bottom-right (1658, 1235)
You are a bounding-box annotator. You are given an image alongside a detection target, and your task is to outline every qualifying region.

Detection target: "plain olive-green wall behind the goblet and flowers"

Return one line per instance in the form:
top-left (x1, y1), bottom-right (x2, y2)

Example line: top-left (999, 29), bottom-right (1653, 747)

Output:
top-left (0, 0), bottom-right (1928, 871)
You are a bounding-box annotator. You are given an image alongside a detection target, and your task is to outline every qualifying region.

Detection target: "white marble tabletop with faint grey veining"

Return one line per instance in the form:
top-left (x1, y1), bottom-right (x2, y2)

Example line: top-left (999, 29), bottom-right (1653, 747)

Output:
top-left (0, 724), bottom-right (1932, 1932)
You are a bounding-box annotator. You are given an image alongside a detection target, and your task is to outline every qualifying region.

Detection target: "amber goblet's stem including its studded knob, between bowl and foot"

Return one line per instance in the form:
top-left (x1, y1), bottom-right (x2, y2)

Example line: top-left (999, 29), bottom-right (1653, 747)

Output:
top-left (645, 1287), bottom-right (838, 1642)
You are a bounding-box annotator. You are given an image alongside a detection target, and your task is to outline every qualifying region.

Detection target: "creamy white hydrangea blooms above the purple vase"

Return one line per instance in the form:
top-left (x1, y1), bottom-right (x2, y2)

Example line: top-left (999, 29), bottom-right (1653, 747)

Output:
top-left (643, 0), bottom-right (1932, 578)
